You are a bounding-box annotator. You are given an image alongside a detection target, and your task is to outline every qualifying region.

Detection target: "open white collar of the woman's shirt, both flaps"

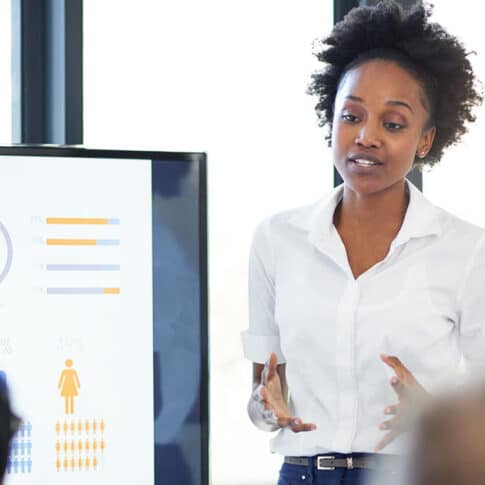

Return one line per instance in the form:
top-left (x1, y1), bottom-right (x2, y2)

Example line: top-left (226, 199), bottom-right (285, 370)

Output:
top-left (290, 180), bottom-right (442, 247)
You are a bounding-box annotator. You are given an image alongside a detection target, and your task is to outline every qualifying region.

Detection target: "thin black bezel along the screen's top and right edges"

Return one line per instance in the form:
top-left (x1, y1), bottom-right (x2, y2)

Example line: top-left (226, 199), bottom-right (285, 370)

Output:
top-left (0, 145), bottom-right (209, 485)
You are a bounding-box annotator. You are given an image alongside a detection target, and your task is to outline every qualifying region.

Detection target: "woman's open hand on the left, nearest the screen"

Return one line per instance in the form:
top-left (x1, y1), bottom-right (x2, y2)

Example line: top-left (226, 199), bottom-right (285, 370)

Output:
top-left (254, 353), bottom-right (316, 433)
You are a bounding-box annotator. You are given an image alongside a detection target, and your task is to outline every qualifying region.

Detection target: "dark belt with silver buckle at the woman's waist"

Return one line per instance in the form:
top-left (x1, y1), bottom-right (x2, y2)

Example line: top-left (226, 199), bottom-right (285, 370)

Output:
top-left (285, 455), bottom-right (400, 470)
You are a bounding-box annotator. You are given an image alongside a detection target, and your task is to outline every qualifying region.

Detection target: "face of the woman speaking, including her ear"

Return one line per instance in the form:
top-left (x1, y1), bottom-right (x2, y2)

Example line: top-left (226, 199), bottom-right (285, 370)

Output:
top-left (332, 60), bottom-right (435, 195)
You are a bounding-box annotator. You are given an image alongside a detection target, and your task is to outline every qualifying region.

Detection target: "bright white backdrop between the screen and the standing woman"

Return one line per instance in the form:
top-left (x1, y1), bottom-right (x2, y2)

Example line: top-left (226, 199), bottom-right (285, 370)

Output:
top-left (84, 0), bottom-right (333, 485)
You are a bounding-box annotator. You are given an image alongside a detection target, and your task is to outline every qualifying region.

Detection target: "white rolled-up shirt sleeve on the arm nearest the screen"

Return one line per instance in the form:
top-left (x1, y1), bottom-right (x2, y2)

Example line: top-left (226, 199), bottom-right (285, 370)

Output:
top-left (242, 220), bottom-right (285, 363)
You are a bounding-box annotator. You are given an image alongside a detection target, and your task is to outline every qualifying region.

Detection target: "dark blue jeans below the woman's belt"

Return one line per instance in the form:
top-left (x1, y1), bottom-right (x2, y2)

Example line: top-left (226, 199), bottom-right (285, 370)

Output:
top-left (278, 453), bottom-right (396, 485)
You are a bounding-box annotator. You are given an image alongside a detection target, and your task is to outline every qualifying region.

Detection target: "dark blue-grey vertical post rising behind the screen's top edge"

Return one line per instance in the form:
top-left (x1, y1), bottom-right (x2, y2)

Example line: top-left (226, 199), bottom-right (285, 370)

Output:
top-left (12, 0), bottom-right (83, 145)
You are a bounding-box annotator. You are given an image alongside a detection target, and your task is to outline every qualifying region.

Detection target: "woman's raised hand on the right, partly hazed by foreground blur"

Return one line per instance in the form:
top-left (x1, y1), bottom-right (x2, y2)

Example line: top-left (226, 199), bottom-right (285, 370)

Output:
top-left (374, 354), bottom-right (430, 452)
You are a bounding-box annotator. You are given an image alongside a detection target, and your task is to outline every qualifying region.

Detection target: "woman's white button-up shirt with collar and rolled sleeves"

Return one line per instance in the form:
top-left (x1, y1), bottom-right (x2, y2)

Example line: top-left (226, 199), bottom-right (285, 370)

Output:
top-left (242, 183), bottom-right (485, 456)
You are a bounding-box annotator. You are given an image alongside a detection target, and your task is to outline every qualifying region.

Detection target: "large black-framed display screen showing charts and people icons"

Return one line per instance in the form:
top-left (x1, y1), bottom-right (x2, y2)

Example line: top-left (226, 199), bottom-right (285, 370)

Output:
top-left (0, 147), bottom-right (208, 485)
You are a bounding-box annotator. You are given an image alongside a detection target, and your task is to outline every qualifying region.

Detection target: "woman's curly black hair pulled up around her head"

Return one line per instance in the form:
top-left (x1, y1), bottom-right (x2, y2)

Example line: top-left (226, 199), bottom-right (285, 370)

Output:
top-left (308, 0), bottom-right (483, 166)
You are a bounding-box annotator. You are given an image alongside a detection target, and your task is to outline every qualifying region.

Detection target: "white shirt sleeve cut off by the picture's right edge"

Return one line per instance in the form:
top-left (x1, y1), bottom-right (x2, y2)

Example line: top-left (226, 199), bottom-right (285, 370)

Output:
top-left (458, 233), bottom-right (485, 379)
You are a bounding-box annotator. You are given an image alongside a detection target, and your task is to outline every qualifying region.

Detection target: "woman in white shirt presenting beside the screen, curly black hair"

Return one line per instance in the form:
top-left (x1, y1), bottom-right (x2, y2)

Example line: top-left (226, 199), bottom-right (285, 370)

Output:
top-left (243, 1), bottom-right (485, 485)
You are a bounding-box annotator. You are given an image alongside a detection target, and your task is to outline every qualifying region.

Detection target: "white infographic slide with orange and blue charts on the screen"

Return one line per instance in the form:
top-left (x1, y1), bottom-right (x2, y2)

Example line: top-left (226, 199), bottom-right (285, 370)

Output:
top-left (0, 157), bottom-right (154, 485)
